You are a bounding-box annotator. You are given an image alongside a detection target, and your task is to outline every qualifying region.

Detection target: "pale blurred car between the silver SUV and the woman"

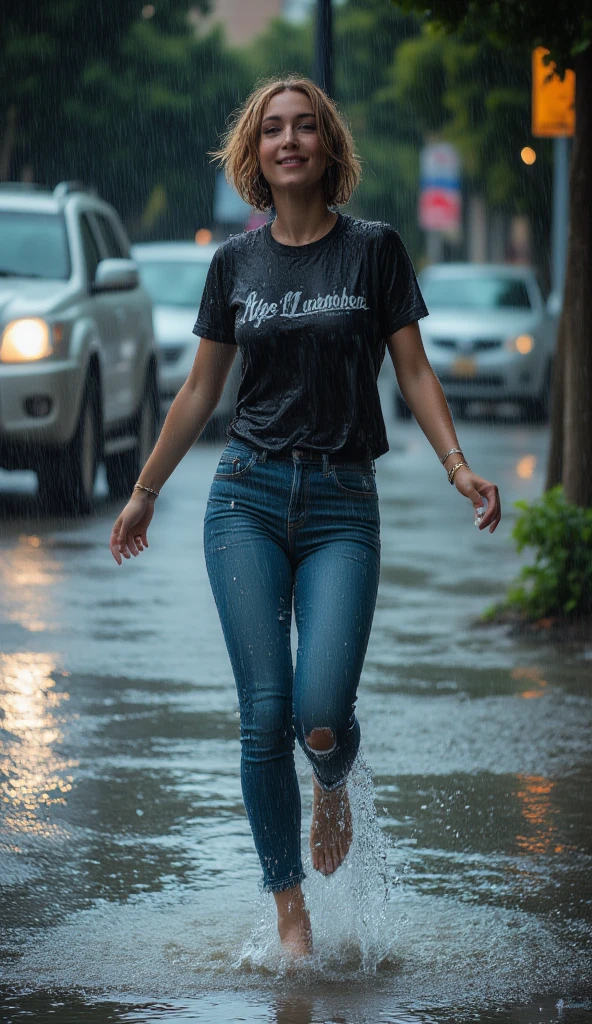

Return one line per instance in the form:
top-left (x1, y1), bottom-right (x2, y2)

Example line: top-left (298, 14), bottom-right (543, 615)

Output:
top-left (131, 242), bottom-right (240, 438)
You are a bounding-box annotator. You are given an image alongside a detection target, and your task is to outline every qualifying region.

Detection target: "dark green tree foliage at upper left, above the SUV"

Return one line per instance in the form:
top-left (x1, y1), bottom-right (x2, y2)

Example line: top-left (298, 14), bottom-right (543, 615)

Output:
top-left (0, 0), bottom-right (246, 237)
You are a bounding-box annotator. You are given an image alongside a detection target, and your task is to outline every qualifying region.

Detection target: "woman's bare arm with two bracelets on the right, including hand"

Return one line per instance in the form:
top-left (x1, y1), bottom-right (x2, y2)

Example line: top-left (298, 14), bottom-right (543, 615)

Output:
top-left (387, 323), bottom-right (502, 534)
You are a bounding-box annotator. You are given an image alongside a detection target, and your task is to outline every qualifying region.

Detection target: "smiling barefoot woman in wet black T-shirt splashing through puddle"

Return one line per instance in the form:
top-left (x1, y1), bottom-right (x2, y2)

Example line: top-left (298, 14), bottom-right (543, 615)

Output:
top-left (111, 78), bottom-right (501, 955)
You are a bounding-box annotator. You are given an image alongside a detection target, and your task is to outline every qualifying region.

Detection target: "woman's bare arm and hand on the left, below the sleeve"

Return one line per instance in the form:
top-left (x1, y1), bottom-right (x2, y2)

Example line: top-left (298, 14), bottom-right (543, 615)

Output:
top-left (110, 338), bottom-right (237, 565)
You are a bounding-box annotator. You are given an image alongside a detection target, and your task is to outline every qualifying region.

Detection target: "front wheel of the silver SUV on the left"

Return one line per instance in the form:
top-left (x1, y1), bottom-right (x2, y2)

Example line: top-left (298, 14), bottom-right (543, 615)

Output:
top-left (37, 377), bottom-right (100, 515)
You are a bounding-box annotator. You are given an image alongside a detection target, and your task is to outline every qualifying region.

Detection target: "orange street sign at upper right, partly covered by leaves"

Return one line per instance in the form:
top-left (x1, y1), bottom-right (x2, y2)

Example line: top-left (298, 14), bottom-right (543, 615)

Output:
top-left (533, 46), bottom-right (576, 138)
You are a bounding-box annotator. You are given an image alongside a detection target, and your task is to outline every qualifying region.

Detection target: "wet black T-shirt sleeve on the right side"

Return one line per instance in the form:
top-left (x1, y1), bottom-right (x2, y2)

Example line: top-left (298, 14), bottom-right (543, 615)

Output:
top-left (378, 224), bottom-right (428, 337)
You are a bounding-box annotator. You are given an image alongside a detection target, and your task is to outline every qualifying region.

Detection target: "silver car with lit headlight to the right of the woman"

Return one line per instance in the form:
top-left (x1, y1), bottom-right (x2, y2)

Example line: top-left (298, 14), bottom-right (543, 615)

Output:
top-left (395, 263), bottom-right (556, 421)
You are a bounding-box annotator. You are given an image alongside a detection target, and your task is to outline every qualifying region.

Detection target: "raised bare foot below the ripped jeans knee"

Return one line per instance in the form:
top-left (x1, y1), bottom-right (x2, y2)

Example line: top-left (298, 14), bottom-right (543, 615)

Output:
top-left (310, 775), bottom-right (352, 874)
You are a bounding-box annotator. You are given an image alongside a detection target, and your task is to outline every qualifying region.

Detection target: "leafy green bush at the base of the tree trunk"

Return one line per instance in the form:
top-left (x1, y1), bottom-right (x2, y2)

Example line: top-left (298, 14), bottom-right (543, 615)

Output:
top-left (506, 486), bottom-right (592, 618)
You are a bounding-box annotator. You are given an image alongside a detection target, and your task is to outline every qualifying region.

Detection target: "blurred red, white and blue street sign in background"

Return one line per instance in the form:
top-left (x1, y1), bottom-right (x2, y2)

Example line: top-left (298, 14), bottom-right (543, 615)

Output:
top-left (419, 142), bottom-right (462, 234)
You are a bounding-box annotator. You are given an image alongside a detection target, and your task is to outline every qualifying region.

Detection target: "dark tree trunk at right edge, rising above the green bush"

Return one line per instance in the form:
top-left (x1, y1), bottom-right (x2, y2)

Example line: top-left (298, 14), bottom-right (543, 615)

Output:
top-left (561, 46), bottom-right (592, 507)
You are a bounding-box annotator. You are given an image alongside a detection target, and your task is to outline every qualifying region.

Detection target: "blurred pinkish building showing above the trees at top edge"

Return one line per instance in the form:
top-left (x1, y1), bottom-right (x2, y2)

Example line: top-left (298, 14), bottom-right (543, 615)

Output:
top-left (191, 0), bottom-right (315, 46)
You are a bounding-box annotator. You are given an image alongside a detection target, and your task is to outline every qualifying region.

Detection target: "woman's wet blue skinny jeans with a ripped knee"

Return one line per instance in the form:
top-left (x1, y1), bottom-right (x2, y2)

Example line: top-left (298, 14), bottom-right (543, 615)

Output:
top-left (204, 438), bottom-right (380, 892)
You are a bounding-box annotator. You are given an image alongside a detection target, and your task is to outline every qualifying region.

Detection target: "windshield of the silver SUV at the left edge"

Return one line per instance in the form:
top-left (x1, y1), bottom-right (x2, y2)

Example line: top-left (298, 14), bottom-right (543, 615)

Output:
top-left (0, 210), bottom-right (71, 281)
